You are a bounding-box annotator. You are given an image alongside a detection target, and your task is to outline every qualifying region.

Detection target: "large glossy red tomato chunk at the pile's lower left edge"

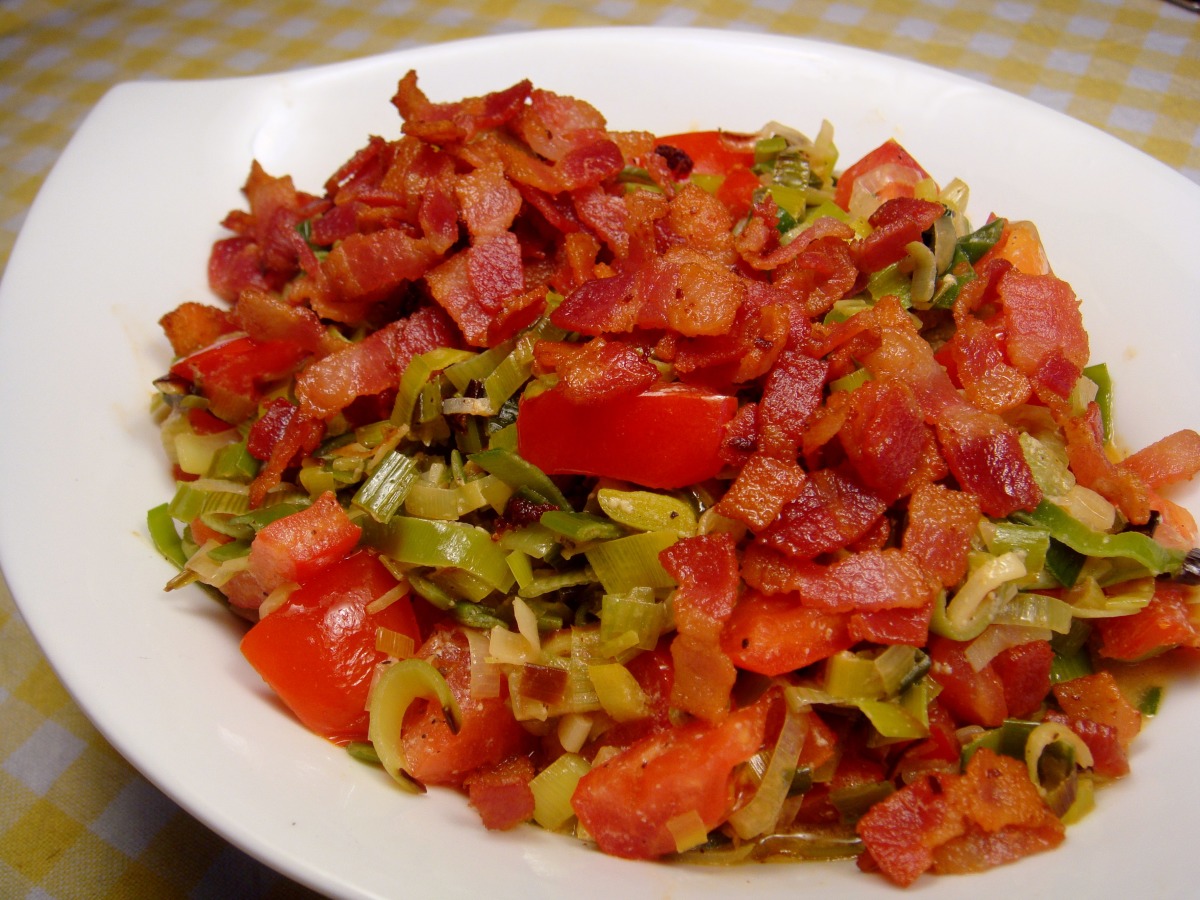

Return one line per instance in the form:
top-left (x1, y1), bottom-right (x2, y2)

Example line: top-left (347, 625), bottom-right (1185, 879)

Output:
top-left (241, 551), bottom-right (419, 743)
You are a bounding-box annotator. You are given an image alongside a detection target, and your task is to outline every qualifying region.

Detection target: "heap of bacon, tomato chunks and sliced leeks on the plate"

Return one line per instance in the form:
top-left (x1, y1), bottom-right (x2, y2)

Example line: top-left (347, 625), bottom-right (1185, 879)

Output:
top-left (149, 72), bottom-right (1200, 884)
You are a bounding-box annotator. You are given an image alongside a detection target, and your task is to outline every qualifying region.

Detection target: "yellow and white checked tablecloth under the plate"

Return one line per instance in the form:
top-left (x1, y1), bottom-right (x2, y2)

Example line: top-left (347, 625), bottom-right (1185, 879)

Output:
top-left (0, 0), bottom-right (1200, 898)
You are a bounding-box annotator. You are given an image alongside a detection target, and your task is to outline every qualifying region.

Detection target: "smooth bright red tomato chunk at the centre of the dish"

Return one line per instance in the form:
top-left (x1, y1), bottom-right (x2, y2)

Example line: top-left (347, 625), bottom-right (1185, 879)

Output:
top-left (517, 384), bottom-right (738, 488)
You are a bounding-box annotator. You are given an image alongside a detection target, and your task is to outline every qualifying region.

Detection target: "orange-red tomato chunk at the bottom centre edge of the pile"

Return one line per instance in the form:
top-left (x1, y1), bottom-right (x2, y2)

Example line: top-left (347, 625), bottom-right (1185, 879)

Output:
top-left (571, 702), bottom-right (767, 859)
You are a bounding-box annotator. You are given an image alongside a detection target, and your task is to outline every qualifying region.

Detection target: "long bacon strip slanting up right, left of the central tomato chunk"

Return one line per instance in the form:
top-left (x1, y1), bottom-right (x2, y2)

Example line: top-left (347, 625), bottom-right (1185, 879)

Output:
top-left (295, 307), bottom-right (458, 418)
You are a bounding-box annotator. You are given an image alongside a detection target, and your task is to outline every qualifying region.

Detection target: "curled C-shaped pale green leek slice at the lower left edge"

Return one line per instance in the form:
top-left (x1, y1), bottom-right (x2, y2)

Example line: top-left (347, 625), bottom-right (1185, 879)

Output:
top-left (367, 658), bottom-right (462, 793)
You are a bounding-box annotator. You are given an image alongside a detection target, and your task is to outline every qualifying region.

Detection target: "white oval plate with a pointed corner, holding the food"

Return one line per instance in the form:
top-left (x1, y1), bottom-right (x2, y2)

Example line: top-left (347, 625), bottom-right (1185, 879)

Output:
top-left (0, 29), bottom-right (1200, 900)
